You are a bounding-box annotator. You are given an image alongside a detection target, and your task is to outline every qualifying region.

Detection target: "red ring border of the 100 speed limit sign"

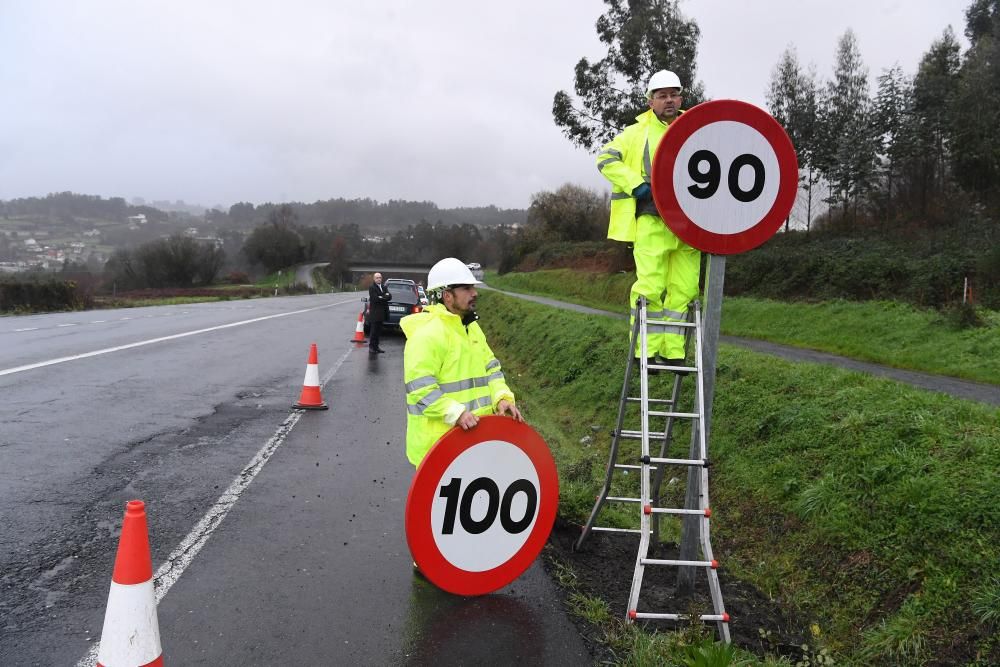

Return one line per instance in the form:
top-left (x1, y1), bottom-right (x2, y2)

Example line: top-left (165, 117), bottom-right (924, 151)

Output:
top-left (406, 415), bottom-right (559, 595)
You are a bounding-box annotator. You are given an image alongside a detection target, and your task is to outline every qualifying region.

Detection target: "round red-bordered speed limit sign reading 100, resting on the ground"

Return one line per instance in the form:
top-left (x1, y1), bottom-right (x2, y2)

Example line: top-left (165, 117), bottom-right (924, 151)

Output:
top-left (406, 415), bottom-right (559, 595)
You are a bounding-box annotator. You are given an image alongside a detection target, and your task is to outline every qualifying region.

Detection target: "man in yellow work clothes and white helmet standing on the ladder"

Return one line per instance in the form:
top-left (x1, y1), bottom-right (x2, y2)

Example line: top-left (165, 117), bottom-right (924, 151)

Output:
top-left (597, 70), bottom-right (701, 366)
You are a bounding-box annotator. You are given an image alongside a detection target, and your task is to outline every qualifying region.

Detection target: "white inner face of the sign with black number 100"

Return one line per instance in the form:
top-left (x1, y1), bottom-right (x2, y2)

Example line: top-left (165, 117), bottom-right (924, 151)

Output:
top-left (431, 440), bottom-right (540, 572)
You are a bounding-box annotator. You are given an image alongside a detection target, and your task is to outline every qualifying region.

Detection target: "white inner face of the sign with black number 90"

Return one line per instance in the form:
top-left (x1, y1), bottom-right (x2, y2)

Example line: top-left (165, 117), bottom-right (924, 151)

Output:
top-left (673, 121), bottom-right (780, 234)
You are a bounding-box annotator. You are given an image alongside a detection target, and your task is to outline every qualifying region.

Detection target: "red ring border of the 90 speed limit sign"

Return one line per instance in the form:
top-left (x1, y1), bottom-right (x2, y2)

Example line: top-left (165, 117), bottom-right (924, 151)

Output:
top-left (651, 100), bottom-right (799, 255)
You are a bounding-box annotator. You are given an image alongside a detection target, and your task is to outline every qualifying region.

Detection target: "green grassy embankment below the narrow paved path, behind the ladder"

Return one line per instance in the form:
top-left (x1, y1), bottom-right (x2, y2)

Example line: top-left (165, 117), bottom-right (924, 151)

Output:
top-left (479, 286), bottom-right (1000, 665)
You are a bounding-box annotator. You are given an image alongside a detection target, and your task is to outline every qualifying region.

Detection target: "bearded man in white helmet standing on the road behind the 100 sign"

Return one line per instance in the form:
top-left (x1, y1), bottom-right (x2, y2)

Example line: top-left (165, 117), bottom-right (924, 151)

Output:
top-left (400, 257), bottom-right (524, 466)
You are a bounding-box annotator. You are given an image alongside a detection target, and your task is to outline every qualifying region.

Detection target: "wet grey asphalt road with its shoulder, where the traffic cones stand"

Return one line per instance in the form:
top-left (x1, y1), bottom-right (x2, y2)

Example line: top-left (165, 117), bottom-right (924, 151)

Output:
top-left (0, 294), bottom-right (590, 665)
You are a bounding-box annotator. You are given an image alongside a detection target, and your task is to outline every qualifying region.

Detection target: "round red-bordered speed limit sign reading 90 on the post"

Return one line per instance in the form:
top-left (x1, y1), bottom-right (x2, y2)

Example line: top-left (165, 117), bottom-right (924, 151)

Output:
top-left (651, 100), bottom-right (799, 255)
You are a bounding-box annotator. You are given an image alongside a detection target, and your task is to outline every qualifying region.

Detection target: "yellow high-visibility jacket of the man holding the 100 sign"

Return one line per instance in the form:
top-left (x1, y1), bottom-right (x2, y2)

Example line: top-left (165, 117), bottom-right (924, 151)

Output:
top-left (399, 303), bottom-right (514, 465)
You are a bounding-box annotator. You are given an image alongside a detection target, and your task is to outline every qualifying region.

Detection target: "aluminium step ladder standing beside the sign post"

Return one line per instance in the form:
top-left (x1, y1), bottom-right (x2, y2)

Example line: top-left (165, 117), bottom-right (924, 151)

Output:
top-left (574, 297), bottom-right (730, 644)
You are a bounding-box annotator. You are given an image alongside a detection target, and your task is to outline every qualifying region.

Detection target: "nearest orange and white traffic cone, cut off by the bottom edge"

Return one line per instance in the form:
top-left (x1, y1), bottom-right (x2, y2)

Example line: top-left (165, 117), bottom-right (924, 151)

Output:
top-left (97, 500), bottom-right (163, 667)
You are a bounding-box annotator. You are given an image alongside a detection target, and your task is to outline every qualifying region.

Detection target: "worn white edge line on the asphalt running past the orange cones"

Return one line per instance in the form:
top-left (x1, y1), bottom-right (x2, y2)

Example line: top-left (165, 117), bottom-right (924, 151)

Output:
top-left (76, 348), bottom-right (354, 667)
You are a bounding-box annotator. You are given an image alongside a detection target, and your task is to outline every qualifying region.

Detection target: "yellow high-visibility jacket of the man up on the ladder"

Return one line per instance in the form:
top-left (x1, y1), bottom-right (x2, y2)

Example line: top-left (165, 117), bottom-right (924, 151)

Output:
top-left (597, 109), bottom-right (684, 242)
